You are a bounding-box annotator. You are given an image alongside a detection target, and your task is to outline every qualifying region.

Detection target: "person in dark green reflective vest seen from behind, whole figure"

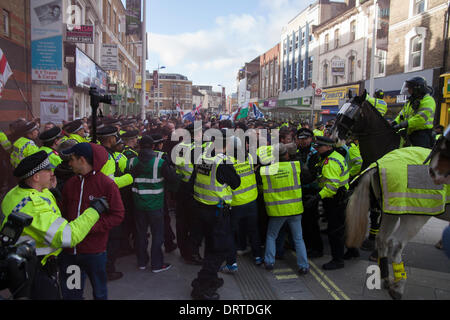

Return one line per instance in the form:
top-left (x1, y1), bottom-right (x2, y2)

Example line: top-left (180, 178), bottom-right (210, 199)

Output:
top-left (127, 136), bottom-right (178, 273)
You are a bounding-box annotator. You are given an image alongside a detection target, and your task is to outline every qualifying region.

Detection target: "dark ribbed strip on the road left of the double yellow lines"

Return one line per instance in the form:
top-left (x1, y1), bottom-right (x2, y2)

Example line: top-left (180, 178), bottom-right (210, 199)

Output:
top-left (235, 256), bottom-right (279, 300)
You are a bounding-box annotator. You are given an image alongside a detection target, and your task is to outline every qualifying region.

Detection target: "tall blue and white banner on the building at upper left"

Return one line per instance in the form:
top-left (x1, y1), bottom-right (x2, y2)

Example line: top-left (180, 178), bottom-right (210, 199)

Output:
top-left (30, 0), bottom-right (63, 84)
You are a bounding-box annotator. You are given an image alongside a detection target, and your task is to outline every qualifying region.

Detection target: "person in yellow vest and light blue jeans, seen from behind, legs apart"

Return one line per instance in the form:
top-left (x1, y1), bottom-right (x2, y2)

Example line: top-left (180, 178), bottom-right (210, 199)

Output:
top-left (259, 143), bottom-right (309, 275)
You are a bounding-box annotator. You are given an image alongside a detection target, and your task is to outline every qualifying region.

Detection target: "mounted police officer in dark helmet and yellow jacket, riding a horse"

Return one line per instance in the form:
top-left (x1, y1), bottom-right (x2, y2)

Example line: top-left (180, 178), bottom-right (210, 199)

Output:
top-left (392, 77), bottom-right (436, 148)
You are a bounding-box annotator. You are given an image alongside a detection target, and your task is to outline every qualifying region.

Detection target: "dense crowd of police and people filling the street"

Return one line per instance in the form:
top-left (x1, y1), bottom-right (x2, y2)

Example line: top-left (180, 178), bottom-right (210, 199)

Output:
top-left (0, 75), bottom-right (446, 300)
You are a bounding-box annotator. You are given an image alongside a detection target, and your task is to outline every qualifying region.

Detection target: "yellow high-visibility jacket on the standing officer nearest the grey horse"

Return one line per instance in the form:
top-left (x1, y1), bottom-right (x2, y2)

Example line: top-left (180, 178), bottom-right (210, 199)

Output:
top-left (318, 151), bottom-right (349, 199)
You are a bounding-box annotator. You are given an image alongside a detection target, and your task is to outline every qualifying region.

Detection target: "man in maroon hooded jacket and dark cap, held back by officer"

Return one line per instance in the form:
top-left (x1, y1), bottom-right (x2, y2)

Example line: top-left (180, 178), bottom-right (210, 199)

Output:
top-left (59, 143), bottom-right (125, 300)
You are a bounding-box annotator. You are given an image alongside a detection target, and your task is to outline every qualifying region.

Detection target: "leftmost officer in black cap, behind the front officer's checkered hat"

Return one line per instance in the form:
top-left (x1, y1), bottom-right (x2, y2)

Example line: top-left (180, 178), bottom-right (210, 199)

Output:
top-left (11, 121), bottom-right (39, 168)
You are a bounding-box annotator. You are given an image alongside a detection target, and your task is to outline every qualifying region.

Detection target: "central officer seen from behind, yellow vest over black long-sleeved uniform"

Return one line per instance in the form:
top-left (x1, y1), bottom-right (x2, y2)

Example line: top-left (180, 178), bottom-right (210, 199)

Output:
top-left (191, 129), bottom-right (241, 300)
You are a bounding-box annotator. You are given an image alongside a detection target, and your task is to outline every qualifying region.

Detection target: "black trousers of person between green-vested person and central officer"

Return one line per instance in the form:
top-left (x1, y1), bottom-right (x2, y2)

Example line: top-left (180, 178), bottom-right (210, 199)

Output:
top-left (175, 191), bottom-right (203, 260)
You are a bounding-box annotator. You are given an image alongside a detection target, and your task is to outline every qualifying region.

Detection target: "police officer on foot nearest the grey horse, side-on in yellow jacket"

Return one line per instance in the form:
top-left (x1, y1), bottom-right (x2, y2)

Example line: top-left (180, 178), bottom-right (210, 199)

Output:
top-left (305, 137), bottom-right (349, 270)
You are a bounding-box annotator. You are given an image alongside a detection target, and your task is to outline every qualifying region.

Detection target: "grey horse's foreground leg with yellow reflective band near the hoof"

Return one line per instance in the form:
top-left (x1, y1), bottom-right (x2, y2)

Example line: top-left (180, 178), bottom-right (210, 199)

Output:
top-left (388, 215), bottom-right (430, 300)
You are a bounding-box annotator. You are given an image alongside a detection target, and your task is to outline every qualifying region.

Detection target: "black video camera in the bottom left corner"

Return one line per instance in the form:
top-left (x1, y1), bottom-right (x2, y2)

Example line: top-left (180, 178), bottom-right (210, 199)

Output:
top-left (0, 212), bottom-right (37, 299)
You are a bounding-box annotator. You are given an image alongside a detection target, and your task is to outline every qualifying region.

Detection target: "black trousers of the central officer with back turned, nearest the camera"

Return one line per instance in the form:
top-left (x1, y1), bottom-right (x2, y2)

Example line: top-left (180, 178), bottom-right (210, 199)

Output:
top-left (194, 201), bottom-right (232, 291)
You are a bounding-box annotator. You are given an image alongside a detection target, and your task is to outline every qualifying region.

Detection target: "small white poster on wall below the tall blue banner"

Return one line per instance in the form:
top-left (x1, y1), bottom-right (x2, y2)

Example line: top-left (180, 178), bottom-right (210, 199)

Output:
top-left (40, 91), bottom-right (67, 124)
